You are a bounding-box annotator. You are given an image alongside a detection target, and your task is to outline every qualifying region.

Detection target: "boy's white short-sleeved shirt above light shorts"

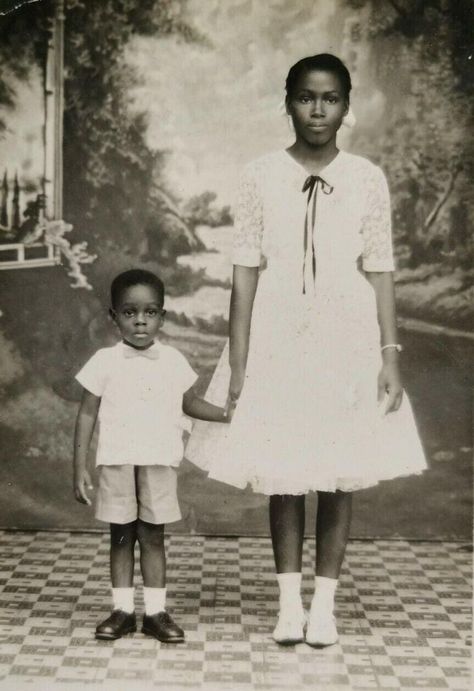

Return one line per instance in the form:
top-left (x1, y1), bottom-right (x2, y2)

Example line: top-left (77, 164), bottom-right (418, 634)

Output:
top-left (76, 341), bottom-right (197, 466)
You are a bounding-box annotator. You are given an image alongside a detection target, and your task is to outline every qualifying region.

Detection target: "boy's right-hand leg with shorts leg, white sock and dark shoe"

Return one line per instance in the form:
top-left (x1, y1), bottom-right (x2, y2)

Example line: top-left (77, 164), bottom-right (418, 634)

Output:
top-left (137, 466), bottom-right (184, 643)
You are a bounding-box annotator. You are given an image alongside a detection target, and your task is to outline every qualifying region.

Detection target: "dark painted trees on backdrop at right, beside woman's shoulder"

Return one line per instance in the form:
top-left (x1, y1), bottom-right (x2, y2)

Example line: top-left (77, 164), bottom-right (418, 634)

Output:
top-left (348, 0), bottom-right (474, 276)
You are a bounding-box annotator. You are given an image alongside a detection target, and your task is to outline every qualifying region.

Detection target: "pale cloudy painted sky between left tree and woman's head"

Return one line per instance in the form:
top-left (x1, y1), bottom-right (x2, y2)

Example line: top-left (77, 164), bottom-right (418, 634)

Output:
top-left (126, 0), bottom-right (360, 203)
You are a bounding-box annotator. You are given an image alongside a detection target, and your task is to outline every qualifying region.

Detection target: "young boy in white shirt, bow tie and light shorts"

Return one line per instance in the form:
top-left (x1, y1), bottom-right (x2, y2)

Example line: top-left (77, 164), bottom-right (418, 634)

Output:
top-left (74, 269), bottom-right (230, 643)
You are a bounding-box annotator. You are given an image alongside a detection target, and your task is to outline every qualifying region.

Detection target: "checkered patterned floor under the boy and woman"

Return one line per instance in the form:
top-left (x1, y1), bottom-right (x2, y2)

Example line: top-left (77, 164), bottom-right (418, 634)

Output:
top-left (0, 532), bottom-right (471, 691)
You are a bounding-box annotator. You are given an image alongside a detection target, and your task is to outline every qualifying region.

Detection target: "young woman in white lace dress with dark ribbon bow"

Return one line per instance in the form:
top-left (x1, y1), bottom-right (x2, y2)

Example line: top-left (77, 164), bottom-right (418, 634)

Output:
top-left (186, 54), bottom-right (425, 646)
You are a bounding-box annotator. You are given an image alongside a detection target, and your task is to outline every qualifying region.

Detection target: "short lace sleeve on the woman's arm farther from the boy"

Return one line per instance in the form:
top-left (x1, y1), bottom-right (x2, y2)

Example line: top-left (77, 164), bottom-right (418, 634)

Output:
top-left (362, 168), bottom-right (395, 271)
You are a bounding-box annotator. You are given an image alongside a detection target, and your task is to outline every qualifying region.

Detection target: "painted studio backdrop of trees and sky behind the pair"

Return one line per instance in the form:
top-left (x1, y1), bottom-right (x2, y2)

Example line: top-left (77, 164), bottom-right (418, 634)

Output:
top-left (0, 0), bottom-right (474, 539)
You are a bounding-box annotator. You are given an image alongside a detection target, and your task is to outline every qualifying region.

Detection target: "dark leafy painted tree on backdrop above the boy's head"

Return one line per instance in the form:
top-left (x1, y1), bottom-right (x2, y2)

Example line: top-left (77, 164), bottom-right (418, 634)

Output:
top-left (0, 0), bottom-right (205, 291)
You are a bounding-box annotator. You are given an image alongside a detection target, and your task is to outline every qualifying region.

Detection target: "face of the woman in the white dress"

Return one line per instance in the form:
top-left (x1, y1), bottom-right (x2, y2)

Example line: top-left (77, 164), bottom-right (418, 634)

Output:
top-left (287, 70), bottom-right (349, 147)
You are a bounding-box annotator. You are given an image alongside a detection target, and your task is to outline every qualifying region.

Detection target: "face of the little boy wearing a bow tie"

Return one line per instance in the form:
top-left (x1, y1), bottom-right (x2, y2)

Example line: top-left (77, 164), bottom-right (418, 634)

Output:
top-left (110, 284), bottom-right (164, 349)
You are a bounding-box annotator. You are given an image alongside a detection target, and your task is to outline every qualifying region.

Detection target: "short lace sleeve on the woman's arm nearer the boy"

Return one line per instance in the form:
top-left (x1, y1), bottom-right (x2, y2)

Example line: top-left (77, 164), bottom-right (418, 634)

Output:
top-left (232, 168), bottom-right (263, 266)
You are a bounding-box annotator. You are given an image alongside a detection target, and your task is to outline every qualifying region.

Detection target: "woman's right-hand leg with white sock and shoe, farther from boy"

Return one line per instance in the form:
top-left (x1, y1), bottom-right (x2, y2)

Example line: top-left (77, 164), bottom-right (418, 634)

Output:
top-left (306, 491), bottom-right (352, 646)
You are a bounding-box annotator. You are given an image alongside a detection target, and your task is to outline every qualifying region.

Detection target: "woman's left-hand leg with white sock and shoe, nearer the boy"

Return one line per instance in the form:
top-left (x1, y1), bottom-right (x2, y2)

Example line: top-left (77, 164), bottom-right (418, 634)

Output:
top-left (270, 495), bottom-right (305, 645)
